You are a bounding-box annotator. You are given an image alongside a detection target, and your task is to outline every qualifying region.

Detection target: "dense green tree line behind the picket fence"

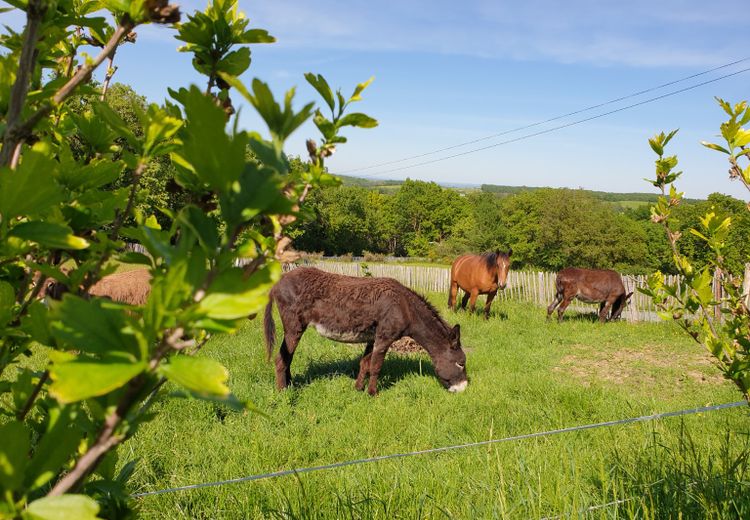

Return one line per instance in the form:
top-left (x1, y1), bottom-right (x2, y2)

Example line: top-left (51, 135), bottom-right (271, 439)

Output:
top-left (294, 180), bottom-right (750, 273)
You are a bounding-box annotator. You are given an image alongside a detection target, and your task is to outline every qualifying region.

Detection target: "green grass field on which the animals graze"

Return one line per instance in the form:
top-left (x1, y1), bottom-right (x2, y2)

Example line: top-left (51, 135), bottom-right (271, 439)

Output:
top-left (128, 295), bottom-right (750, 519)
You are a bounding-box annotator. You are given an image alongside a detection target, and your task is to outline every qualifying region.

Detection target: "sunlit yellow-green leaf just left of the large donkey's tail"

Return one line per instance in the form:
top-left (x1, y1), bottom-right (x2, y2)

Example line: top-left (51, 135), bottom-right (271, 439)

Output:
top-left (198, 262), bottom-right (281, 320)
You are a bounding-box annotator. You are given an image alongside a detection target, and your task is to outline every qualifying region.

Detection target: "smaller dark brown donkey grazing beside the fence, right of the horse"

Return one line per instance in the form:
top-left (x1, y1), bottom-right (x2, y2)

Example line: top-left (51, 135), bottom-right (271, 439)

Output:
top-left (547, 267), bottom-right (633, 323)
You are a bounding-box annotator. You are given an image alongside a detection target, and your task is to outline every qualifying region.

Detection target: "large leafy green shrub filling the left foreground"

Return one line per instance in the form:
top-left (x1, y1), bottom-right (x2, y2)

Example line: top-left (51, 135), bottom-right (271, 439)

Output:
top-left (0, 0), bottom-right (377, 519)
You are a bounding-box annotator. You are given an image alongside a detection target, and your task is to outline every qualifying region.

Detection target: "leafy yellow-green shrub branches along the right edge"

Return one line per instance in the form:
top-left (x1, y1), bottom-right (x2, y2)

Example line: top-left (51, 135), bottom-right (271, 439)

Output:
top-left (643, 99), bottom-right (750, 400)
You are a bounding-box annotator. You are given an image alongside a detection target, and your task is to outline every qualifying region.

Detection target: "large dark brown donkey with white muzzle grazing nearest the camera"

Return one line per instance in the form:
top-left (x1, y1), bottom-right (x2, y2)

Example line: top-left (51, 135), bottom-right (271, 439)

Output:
top-left (264, 267), bottom-right (467, 395)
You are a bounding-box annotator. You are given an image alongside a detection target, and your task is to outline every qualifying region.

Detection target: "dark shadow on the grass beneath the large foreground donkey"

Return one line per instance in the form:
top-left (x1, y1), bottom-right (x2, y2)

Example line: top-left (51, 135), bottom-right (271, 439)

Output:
top-left (292, 349), bottom-right (435, 391)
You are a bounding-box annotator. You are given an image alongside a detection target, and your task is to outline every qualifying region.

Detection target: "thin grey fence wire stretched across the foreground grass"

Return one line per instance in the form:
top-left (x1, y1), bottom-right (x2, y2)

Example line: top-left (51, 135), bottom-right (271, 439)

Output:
top-left (131, 401), bottom-right (747, 498)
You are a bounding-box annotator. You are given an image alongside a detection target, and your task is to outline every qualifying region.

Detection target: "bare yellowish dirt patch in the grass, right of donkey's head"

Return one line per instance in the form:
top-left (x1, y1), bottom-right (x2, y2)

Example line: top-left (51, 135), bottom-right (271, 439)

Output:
top-left (553, 345), bottom-right (725, 386)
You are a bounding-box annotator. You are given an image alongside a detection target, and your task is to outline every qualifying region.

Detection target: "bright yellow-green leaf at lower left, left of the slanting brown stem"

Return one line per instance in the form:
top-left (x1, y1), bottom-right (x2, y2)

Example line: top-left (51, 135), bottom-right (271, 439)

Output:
top-left (49, 356), bottom-right (148, 403)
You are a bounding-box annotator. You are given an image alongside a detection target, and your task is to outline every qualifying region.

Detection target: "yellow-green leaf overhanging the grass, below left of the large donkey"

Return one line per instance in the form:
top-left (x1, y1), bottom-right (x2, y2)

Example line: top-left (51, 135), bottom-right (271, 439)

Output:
top-left (159, 356), bottom-right (229, 397)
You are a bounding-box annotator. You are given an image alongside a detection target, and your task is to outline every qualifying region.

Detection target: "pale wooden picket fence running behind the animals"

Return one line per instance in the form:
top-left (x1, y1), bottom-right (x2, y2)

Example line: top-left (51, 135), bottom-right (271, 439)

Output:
top-left (292, 260), bottom-right (750, 322)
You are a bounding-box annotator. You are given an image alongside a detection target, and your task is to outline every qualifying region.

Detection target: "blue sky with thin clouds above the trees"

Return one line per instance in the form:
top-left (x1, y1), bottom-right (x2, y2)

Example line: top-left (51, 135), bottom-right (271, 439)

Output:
top-left (0, 0), bottom-right (750, 199)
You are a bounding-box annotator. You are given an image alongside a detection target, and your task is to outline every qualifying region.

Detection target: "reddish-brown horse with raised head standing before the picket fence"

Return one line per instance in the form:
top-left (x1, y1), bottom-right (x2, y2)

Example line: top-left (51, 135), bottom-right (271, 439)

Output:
top-left (448, 249), bottom-right (513, 319)
